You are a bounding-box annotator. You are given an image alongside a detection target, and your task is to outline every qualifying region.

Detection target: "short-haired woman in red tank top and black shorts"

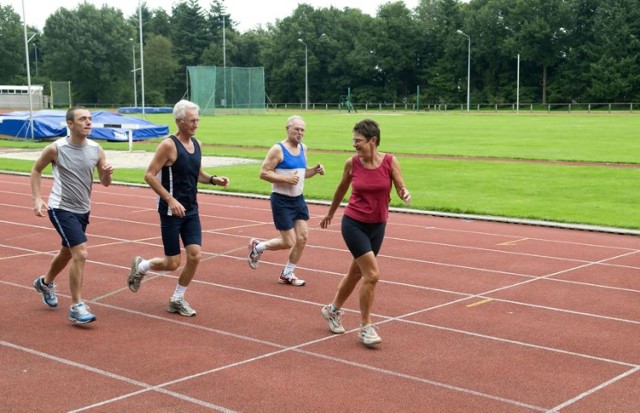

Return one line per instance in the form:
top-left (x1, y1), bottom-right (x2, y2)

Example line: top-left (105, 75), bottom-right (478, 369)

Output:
top-left (320, 119), bottom-right (411, 346)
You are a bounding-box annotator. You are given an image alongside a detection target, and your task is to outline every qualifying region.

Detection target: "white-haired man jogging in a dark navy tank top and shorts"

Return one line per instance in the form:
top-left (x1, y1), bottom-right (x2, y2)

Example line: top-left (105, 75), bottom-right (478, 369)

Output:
top-left (127, 100), bottom-right (229, 317)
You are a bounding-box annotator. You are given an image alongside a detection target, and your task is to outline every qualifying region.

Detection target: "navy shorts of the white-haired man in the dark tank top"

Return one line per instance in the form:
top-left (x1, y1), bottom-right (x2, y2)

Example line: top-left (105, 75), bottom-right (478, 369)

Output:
top-left (160, 213), bottom-right (202, 257)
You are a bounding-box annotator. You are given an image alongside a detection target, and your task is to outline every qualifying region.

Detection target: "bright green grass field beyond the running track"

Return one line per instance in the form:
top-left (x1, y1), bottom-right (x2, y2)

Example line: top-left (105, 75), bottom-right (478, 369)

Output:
top-left (0, 111), bottom-right (640, 229)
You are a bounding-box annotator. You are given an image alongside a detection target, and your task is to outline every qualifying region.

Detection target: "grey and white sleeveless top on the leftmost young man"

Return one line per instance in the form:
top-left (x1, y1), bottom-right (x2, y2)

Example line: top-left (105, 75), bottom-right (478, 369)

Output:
top-left (48, 137), bottom-right (100, 214)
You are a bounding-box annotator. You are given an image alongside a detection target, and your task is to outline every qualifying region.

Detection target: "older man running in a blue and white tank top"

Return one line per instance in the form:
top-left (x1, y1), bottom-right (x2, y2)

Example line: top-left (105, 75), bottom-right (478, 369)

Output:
top-left (247, 116), bottom-right (324, 287)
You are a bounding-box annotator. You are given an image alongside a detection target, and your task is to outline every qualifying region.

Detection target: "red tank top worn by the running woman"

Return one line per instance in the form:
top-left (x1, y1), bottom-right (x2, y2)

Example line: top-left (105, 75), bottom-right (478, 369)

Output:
top-left (344, 153), bottom-right (393, 223)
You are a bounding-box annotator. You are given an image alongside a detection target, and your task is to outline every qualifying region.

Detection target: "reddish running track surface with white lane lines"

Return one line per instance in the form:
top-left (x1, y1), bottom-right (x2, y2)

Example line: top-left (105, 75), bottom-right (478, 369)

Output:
top-left (0, 175), bottom-right (640, 413)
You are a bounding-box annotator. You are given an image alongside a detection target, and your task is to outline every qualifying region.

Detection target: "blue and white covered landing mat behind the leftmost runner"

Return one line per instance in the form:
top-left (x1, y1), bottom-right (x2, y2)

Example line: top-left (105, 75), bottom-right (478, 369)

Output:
top-left (0, 110), bottom-right (169, 142)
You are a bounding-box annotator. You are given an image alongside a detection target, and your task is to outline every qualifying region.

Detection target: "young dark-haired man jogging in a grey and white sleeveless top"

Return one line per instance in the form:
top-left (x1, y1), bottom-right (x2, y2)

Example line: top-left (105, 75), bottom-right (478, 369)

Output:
top-left (31, 107), bottom-right (113, 324)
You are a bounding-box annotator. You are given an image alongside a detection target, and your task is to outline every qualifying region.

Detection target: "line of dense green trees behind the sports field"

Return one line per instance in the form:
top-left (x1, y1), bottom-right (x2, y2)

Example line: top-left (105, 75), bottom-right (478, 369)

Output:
top-left (0, 0), bottom-right (640, 106)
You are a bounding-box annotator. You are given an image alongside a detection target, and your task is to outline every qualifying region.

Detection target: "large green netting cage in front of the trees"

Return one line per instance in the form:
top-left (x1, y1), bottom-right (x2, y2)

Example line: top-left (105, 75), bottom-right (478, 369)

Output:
top-left (187, 66), bottom-right (266, 115)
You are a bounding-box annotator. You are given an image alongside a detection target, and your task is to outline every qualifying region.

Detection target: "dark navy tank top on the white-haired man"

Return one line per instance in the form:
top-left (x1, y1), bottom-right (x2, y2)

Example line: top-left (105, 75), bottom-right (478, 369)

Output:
top-left (158, 135), bottom-right (202, 215)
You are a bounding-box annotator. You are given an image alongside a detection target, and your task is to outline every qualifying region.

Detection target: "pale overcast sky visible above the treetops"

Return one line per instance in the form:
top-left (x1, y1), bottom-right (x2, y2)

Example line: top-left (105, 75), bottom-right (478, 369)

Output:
top-left (10, 0), bottom-right (418, 32)
